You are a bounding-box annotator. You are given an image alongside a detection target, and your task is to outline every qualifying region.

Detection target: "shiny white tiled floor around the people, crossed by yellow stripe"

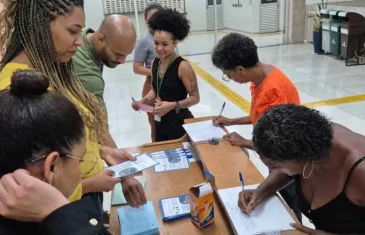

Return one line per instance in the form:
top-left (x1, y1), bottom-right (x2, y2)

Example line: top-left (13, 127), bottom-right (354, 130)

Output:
top-left (104, 39), bottom-right (365, 228)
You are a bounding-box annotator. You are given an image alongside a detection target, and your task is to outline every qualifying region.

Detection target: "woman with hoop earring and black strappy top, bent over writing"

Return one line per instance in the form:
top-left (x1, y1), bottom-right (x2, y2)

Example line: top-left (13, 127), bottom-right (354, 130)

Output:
top-left (239, 105), bottom-right (365, 234)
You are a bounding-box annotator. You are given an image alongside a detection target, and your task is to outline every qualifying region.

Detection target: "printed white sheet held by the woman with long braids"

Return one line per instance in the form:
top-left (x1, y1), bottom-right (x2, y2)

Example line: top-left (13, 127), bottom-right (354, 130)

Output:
top-left (105, 154), bottom-right (158, 178)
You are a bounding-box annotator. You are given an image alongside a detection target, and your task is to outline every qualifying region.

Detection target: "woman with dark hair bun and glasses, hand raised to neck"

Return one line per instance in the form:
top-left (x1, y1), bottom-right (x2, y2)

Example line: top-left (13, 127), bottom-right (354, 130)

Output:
top-left (0, 70), bottom-right (111, 235)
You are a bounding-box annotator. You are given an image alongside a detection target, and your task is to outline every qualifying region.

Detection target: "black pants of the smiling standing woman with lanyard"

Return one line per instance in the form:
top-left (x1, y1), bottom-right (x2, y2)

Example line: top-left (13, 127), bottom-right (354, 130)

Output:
top-left (155, 109), bottom-right (194, 142)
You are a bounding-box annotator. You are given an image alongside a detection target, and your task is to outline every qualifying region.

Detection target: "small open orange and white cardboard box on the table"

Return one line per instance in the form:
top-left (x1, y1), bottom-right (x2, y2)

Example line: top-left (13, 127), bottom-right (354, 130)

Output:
top-left (190, 183), bottom-right (214, 229)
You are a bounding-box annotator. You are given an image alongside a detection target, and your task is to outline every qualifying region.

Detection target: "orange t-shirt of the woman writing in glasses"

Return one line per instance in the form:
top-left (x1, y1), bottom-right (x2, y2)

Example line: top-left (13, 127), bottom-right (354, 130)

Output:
top-left (250, 67), bottom-right (300, 126)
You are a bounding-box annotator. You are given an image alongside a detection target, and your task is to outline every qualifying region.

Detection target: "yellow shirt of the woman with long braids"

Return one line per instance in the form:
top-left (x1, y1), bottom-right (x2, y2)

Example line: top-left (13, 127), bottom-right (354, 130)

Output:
top-left (0, 63), bottom-right (104, 201)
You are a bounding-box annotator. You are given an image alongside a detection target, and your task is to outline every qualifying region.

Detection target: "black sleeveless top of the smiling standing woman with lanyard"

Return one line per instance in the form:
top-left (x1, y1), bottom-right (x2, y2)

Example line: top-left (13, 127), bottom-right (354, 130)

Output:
top-left (152, 56), bottom-right (188, 102)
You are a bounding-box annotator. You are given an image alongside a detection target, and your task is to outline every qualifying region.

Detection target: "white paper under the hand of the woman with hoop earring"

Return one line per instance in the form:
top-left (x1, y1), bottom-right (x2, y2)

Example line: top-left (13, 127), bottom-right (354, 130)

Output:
top-left (218, 185), bottom-right (294, 235)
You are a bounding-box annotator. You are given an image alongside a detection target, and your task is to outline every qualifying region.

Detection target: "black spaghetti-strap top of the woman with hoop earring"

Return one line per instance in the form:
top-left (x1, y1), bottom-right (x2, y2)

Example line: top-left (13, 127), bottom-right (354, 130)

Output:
top-left (296, 156), bottom-right (365, 234)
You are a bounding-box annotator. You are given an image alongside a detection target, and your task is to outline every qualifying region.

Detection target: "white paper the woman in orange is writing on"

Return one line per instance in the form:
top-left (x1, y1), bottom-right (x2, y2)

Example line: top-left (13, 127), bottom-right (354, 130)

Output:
top-left (183, 120), bottom-right (227, 142)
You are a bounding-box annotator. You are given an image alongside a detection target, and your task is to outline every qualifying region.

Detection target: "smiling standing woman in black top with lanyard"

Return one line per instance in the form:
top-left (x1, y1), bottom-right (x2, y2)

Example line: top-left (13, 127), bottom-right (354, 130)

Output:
top-left (133, 9), bottom-right (200, 141)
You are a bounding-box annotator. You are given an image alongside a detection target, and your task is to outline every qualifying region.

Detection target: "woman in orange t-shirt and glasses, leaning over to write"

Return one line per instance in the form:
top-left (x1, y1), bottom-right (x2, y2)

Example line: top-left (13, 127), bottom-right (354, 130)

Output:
top-left (212, 33), bottom-right (302, 220)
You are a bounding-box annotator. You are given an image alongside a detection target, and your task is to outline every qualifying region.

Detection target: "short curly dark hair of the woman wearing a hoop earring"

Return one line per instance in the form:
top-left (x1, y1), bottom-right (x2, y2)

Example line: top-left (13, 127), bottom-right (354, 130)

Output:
top-left (252, 104), bottom-right (333, 162)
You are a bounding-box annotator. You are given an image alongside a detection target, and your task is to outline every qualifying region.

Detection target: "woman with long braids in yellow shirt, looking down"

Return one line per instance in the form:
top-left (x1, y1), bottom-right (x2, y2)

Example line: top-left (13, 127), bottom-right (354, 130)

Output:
top-left (0, 0), bottom-right (146, 209)
